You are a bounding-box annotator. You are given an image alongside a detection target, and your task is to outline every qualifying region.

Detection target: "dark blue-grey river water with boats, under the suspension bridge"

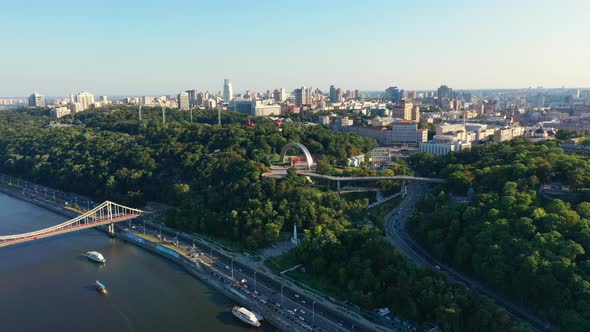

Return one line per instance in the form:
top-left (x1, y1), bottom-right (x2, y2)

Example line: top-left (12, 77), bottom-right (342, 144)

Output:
top-left (0, 193), bottom-right (275, 332)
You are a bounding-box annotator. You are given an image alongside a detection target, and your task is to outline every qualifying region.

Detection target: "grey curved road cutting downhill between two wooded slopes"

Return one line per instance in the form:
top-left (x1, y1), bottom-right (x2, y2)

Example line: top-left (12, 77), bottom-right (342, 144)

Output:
top-left (385, 183), bottom-right (557, 331)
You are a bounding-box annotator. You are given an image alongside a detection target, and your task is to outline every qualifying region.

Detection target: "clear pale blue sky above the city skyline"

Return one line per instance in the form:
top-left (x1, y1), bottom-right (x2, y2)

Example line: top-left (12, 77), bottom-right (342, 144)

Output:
top-left (0, 0), bottom-right (590, 96)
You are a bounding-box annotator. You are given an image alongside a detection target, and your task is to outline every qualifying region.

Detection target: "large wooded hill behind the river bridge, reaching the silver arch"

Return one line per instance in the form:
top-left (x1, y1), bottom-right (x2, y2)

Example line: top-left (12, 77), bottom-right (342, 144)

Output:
top-left (0, 108), bottom-right (376, 247)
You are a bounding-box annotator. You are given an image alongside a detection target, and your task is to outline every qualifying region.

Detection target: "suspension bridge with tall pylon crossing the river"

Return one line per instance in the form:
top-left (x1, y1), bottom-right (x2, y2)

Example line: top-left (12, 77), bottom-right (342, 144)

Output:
top-left (0, 201), bottom-right (144, 247)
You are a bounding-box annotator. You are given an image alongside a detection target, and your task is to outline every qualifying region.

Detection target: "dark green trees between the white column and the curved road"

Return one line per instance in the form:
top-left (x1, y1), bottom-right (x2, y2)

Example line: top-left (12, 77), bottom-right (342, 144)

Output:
top-left (293, 214), bottom-right (531, 331)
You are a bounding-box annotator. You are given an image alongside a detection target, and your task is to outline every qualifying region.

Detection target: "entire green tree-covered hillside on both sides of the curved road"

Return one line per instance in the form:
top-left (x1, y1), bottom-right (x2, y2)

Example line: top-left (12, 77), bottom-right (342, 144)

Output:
top-left (0, 107), bottom-right (560, 331)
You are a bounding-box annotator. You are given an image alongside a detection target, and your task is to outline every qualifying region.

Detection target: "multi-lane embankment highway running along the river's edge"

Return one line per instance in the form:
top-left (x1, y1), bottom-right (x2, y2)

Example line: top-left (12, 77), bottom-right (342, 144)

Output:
top-left (0, 174), bottom-right (388, 332)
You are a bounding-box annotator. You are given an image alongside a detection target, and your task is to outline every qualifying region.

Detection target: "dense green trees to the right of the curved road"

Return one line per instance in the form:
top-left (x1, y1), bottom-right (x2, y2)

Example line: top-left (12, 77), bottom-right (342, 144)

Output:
top-left (409, 140), bottom-right (590, 331)
